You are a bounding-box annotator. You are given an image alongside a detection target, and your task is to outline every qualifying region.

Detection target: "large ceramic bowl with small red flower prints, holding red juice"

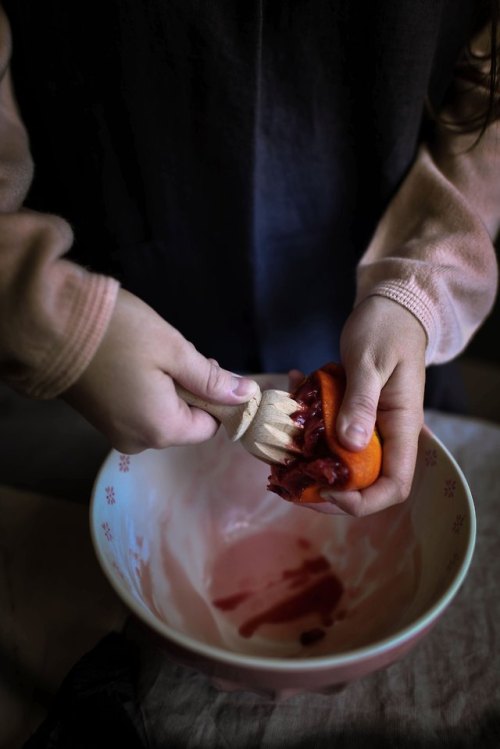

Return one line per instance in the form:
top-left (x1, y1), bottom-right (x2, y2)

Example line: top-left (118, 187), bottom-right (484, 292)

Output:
top-left (91, 382), bottom-right (476, 693)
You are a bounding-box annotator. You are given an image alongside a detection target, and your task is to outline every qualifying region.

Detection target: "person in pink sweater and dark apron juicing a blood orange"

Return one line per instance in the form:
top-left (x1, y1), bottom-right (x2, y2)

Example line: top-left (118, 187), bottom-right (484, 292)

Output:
top-left (0, 0), bottom-right (500, 516)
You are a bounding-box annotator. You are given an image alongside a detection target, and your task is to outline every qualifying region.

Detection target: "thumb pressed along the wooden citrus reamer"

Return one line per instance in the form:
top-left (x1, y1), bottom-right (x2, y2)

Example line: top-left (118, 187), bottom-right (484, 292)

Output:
top-left (175, 350), bottom-right (259, 405)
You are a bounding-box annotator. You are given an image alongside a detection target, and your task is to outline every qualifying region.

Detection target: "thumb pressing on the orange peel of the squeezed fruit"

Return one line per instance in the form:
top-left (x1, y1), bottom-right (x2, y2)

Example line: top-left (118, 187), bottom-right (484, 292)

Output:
top-left (336, 366), bottom-right (381, 450)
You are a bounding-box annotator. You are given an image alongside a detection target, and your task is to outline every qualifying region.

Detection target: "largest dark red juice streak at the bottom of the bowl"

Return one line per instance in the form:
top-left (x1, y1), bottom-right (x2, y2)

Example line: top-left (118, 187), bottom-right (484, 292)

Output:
top-left (238, 574), bottom-right (343, 637)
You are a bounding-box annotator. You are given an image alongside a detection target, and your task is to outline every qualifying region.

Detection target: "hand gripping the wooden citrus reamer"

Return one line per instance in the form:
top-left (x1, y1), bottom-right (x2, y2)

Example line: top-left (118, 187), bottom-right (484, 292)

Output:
top-left (62, 289), bottom-right (257, 454)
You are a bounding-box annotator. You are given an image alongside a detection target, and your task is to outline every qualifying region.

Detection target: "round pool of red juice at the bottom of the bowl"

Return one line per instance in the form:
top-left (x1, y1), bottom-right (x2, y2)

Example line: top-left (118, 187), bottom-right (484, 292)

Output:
top-left (210, 530), bottom-right (344, 651)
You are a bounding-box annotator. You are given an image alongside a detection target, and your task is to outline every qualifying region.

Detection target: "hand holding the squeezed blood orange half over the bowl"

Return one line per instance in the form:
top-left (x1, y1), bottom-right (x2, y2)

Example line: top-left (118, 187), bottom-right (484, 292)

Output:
top-left (310, 296), bottom-right (426, 516)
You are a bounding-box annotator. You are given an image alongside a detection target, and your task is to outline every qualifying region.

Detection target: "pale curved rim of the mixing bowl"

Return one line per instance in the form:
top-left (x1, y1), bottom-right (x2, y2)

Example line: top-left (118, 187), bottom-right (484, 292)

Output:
top-left (89, 424), bottom-right (477, 674)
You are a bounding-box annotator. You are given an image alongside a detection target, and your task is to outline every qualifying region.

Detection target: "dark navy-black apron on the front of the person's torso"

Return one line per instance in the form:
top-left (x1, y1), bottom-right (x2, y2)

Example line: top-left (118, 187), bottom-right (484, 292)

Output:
top-left (4, 0), bottom-right (484, 392)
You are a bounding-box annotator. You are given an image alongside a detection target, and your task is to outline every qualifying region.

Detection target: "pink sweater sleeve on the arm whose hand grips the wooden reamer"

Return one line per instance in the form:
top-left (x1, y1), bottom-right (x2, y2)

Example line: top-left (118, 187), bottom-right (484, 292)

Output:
top-left (0, 7), bottom-right (118, 398)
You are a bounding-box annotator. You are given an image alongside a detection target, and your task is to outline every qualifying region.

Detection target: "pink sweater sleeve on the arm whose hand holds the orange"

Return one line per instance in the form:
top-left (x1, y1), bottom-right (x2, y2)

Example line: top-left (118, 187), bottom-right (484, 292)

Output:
top-left (356, 23), bottom-right (500, 364)
